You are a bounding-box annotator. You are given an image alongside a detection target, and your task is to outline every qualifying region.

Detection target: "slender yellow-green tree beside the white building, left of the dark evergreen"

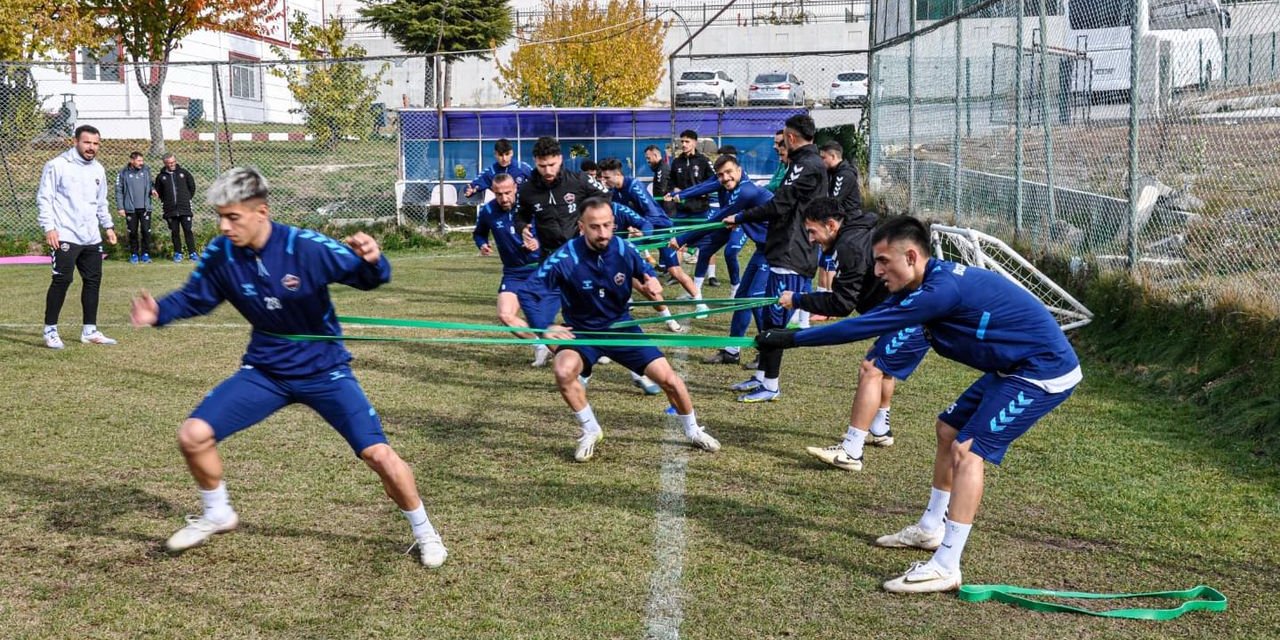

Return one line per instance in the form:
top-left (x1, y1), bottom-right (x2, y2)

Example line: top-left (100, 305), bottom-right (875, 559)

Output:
top-left (271, 12), bottom-right (389, 148)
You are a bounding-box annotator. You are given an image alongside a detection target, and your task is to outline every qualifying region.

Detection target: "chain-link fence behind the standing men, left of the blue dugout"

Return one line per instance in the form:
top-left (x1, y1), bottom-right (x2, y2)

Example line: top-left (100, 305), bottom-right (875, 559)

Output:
top-left (0, 56), bottom-right (430, 248)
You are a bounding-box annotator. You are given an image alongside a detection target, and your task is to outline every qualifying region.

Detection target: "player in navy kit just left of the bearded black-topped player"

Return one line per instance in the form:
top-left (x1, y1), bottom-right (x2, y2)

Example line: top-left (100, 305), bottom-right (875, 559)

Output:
top-left (471, 173), bottom-right (550, 366)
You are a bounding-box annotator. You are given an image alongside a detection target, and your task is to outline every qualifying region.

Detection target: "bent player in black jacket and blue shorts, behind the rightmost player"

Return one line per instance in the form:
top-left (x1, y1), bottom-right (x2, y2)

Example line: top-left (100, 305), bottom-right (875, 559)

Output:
top-left (778, 198), bottom-right (929, 471)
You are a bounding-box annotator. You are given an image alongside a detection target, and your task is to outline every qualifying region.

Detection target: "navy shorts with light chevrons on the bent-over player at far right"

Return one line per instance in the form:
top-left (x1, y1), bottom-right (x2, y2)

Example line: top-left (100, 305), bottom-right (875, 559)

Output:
top-left (938, 374), bottom-right (1075, 465)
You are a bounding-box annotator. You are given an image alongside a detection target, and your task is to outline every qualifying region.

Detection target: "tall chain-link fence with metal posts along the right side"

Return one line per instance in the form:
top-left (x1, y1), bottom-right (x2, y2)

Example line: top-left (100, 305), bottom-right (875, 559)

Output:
top-left (870, 0), bottom-right (1280, 314)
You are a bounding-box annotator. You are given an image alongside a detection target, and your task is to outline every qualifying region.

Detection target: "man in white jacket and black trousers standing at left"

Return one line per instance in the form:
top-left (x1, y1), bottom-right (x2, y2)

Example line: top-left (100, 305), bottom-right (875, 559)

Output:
top-left (36, 124), bottom-right (115, 349)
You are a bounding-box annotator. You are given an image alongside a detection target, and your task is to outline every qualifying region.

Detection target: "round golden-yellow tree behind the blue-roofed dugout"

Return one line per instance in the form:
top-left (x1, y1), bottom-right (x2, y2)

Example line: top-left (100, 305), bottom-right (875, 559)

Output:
top-left (498, 0), bottom-right (671, 106)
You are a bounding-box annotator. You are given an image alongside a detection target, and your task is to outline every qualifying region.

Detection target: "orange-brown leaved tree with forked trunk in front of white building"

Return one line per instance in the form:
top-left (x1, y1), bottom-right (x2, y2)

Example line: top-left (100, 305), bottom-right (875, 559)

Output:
top-left (83, 0), bottom-right (280, 154)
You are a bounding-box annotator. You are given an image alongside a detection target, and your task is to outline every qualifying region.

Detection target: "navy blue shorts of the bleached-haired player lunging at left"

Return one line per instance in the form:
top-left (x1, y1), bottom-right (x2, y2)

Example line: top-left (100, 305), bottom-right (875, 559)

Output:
top-left (191, 365), bottom-right (387, 456)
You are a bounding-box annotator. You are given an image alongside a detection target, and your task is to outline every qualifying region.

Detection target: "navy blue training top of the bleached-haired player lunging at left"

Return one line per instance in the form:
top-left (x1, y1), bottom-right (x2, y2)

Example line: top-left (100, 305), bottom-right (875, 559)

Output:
top-left (156, 221), bottom-right (392, 378)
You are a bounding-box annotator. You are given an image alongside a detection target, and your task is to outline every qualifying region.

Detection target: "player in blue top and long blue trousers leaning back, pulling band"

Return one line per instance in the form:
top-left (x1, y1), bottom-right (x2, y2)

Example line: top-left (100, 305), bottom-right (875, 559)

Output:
top-left (671, 155), bottom-right (773, 365)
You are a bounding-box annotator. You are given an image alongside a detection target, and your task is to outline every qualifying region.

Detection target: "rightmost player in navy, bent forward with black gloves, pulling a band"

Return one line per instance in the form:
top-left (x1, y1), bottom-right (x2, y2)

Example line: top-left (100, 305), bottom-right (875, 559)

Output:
top-left (756, 216), bottom-right (1083, 593)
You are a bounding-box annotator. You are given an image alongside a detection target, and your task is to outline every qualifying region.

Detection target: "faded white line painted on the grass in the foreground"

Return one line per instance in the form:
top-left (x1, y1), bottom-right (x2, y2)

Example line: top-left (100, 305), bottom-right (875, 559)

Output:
top-left (644, 347), bottom-right (689, 640)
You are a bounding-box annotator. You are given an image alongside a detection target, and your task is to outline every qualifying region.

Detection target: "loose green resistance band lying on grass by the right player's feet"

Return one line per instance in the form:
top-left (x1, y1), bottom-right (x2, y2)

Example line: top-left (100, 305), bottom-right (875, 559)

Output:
top-left (959, 585), bottom-right (1226, 621)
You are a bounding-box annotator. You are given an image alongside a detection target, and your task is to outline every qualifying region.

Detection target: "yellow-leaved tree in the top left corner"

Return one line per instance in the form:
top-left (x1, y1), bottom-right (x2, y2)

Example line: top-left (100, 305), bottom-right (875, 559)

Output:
top-left (0, 0), bottom-right (99, 152)
